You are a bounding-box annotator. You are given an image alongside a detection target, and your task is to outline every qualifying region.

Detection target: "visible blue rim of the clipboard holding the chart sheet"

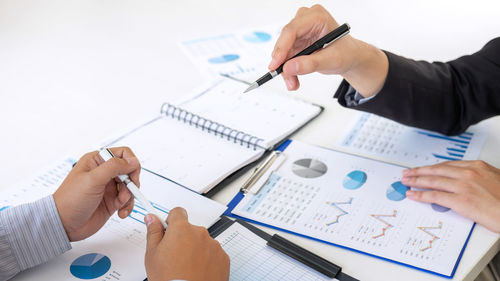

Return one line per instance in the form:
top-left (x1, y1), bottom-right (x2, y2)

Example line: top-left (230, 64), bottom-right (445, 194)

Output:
top-left (224, 139), bottom-right (476, 279)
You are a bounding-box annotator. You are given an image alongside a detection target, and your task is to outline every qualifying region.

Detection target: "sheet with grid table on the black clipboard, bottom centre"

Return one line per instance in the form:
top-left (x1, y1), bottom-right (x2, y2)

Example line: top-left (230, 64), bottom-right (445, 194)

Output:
top-left (215, 223), bottom-right (338, 281)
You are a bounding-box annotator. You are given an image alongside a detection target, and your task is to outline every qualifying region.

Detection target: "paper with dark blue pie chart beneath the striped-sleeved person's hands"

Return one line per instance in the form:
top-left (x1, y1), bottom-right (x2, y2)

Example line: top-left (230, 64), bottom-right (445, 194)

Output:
top-left (0, 158), bottom-right (226, 281)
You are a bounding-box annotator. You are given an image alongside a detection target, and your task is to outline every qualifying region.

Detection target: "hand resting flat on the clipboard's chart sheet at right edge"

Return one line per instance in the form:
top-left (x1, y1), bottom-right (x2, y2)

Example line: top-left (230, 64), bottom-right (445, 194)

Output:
top-left (401, 161), bottom-right (500, 233)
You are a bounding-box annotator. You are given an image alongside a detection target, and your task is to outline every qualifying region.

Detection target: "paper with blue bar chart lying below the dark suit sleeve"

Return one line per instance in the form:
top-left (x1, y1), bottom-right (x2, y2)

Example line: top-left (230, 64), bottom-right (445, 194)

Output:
top-left (335, 113), bottom-right (488, 167)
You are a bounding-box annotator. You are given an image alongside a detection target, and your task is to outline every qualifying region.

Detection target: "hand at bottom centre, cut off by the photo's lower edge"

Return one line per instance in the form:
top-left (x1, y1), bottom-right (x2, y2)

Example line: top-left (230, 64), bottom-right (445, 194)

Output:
top-left (144, 208), bottom-right (229, 281)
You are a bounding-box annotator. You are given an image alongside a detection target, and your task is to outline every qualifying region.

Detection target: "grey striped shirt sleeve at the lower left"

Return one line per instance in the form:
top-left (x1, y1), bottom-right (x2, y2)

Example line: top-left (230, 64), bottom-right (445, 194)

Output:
top-left (0, 195), bottom-right (71, 281)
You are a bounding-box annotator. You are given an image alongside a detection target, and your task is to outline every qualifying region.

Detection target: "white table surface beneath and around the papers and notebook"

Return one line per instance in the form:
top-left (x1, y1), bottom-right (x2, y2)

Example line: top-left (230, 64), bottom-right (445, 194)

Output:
top-left (0, 0), bottom-right (500, 280)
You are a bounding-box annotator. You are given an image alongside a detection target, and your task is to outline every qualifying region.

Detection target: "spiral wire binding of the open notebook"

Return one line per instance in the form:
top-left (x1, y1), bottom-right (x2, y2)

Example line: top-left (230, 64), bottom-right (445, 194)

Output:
top-left (161, 103), bottom-right (266, 150)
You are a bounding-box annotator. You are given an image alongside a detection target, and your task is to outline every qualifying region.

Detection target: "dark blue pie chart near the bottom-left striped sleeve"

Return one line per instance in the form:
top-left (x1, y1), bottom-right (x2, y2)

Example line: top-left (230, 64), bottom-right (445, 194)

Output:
top-left (69, 253), bottom-right (111, 279)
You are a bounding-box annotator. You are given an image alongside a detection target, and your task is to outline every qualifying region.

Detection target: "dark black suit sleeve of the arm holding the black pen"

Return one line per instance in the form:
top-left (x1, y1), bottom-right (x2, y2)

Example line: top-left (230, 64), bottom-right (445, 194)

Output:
top-left (335, 37), bottom-right (500, 135)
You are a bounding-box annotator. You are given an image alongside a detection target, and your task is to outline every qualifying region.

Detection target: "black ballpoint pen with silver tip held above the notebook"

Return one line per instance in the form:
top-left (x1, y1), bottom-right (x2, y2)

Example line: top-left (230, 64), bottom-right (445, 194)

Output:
top-left (243, 23), bottom-right (351, 93)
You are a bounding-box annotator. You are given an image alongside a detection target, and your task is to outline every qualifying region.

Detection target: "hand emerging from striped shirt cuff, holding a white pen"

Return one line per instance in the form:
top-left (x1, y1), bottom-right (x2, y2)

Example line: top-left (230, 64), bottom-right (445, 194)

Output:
top-left (54, 147), bottom-right (141, 241)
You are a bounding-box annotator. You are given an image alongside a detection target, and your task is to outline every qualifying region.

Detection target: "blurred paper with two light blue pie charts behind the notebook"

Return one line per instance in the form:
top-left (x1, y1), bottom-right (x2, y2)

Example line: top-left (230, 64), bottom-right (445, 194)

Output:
top-left (179, 26), bottom-right (281, 81)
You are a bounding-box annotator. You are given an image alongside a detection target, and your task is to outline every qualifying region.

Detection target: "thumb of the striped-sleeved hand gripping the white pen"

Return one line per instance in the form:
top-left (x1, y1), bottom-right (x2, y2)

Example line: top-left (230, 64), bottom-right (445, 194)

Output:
top-left (90, 157), bottom-right (141, 184)
